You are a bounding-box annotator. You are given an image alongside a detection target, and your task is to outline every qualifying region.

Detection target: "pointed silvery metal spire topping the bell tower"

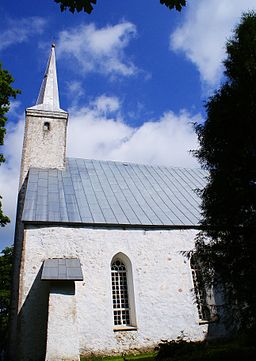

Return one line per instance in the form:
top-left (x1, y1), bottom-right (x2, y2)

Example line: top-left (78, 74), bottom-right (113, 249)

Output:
top-left (29, 44), bottom-right (64, 112)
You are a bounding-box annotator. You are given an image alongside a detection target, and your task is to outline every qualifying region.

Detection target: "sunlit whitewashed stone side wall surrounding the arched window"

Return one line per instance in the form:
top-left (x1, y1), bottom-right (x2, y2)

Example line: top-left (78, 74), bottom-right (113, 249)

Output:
top-left (18, 226), bottom-right (210, 360)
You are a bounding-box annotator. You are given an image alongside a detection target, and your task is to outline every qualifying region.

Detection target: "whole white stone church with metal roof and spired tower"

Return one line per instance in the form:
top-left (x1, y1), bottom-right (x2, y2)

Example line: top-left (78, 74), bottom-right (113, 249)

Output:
top-left (10, 45), bottom-right (222, 361)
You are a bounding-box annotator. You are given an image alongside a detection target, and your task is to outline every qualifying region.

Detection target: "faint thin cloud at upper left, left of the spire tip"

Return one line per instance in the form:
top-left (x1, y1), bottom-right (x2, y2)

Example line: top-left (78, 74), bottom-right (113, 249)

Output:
top-left (0, 16), bottom-right (46, 51)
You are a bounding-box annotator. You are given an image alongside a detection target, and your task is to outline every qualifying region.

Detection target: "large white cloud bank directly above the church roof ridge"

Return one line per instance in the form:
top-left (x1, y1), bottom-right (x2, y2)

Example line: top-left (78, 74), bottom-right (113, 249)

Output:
top-left (68, 95), bottom-right (201, 167)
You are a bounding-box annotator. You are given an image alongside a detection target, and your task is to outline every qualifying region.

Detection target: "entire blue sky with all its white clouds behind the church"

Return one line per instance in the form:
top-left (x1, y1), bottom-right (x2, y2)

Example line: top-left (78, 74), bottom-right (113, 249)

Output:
top-left (0, 0), bottom-right (255, 248)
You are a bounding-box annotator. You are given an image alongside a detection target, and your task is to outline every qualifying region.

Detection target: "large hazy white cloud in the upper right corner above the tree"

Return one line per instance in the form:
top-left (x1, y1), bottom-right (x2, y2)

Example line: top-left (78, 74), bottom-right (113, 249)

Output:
top-left (170, 0), bottom-right (255, 86)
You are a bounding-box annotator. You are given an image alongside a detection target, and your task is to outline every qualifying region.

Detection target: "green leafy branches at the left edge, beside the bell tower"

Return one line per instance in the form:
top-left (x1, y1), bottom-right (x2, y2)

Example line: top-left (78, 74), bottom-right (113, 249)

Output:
top-left (0, 64), bottom-right (20, 227)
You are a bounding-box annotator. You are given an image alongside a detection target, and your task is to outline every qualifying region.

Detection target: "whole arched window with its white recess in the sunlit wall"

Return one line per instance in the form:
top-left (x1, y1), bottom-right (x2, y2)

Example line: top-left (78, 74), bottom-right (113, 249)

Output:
top-left (111, 253), bottom-right (136, 327)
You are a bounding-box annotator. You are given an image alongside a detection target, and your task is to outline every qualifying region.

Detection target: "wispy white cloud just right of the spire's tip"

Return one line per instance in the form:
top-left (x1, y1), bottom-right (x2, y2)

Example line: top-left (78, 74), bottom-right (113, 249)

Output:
top-left (58, 22), bottom-right (138, 76)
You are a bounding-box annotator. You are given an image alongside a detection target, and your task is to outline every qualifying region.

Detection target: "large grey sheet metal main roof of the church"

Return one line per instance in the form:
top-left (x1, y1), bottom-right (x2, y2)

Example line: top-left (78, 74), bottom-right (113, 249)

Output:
top-left (23, 158), bottom-right (206, 226)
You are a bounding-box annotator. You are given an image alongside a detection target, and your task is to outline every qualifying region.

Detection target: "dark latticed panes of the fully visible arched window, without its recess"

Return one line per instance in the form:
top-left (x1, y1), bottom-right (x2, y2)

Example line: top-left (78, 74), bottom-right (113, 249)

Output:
top-left (111, 260), bottom-right (130, 326)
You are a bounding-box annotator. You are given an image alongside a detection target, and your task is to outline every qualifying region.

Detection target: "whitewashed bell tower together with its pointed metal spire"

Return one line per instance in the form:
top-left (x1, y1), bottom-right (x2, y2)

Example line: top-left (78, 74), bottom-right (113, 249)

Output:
top-left (20, 44), bottom-right (68, 187)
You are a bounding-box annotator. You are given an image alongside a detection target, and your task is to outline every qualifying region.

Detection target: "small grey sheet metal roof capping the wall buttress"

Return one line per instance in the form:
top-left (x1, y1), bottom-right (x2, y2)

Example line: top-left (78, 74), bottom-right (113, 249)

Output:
top-left (41, 258), bottom-right (83, 281)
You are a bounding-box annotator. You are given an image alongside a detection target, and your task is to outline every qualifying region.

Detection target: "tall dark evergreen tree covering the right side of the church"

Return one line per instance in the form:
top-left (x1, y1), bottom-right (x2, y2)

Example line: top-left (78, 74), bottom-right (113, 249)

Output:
top-left (195, 12), bottom-right (256, 329)
